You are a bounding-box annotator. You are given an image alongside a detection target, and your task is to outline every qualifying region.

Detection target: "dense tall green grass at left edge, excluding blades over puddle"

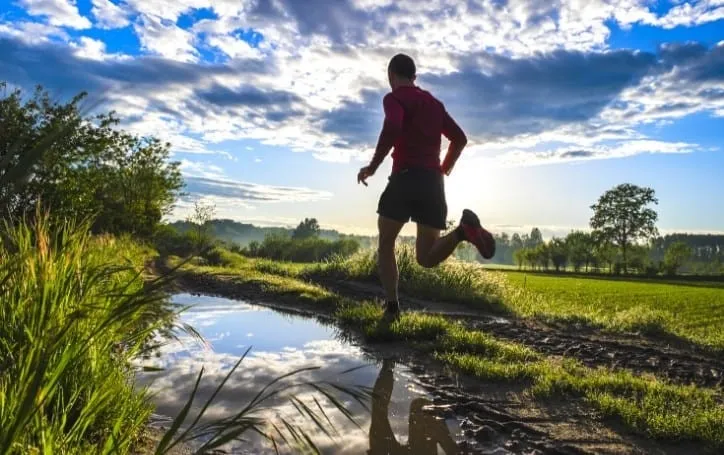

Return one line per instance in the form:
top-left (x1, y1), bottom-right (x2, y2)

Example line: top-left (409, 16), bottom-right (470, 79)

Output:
top-left (0, 216), bottom-right (172, 453)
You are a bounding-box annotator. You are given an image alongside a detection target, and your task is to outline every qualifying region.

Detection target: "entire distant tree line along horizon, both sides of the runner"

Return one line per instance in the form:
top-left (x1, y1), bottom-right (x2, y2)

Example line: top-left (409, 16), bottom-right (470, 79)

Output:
top-left (165, 191), bottom-right (724, 276)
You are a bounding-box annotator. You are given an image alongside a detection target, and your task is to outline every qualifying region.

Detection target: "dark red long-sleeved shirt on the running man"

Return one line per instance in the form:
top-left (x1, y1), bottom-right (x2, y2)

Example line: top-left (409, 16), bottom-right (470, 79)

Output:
top-left (371, 86), bottom-right (466, 173)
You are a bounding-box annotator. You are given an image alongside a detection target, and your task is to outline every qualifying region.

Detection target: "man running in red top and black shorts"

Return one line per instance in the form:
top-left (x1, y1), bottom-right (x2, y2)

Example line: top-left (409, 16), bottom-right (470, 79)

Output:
top-left (357, 54), bottom-right (495, 317)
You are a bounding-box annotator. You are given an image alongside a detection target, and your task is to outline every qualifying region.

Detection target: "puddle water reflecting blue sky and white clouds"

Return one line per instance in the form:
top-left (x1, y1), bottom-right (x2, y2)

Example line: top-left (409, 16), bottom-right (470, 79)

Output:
top-left (138, 295), bottom-right (458, 454)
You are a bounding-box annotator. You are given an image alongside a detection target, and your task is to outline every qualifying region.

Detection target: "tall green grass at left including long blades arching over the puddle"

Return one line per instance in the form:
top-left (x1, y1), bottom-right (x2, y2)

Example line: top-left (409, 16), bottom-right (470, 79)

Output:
top-left (0, 215), bottom-right (369, 454)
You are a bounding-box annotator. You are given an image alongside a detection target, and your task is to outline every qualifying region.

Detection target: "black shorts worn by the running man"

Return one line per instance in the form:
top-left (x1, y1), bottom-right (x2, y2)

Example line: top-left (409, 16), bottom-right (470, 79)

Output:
top-left (377, 168), bottom-right (447, 230)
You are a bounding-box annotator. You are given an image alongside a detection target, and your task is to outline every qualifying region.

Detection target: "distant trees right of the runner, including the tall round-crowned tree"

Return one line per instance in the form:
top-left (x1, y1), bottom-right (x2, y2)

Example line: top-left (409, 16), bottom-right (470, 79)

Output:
top-left (456, 184), bottom-right (724, 276)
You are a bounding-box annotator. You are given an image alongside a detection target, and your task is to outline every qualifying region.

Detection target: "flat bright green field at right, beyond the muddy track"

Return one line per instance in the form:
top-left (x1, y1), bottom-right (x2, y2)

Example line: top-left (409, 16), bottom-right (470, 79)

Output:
top-left (506, 272), bottom-right (724, 349)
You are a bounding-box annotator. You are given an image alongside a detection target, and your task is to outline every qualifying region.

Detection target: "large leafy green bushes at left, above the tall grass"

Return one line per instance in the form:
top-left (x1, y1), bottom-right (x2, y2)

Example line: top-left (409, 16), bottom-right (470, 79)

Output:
top-left (0, 83), bottom-right (183, 237)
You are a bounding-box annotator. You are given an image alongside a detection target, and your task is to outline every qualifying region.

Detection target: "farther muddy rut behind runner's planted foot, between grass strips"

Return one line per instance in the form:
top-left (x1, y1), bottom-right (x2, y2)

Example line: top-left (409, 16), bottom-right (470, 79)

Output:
top-left (319, 280), bottom-right (724, 388)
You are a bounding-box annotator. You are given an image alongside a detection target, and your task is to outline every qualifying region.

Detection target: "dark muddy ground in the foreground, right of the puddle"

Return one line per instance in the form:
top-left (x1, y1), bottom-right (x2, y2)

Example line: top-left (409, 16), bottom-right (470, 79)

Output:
top-left (354, 343), bottom-right (717, 455)
